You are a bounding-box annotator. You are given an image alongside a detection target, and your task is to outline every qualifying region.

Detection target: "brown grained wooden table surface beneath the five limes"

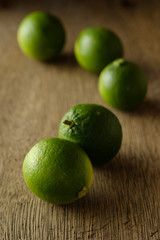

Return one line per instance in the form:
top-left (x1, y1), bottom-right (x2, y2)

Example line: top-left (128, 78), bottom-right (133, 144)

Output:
top-left (0, 0), bottom-right (160, 240)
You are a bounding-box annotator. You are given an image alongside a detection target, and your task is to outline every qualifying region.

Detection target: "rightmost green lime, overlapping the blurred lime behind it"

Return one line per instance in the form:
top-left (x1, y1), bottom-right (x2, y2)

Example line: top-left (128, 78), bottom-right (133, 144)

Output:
top-left (99, 59), bottom-right (147, 111)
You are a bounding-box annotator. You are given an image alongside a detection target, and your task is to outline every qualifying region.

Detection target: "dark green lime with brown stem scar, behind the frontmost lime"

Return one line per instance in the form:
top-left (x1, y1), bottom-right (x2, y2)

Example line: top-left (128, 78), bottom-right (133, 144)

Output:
top-left (59, 104), bottom-right (122, 165)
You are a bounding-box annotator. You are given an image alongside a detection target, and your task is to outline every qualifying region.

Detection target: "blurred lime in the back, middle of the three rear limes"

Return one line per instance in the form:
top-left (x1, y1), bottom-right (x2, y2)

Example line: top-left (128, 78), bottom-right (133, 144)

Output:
top-left (74, 27), bottom-right (123, 73)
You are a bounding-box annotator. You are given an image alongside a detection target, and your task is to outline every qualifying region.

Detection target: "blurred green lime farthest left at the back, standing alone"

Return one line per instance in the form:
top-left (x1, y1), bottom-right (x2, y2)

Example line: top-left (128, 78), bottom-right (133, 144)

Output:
top-left (17, 11), bottom-right (65, 61)
